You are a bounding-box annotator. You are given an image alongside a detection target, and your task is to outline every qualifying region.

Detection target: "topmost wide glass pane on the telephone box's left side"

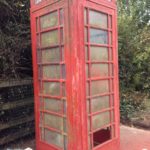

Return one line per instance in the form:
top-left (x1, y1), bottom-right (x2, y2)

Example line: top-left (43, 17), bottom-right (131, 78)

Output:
top-left (40, 11), bottom-right (58, 29)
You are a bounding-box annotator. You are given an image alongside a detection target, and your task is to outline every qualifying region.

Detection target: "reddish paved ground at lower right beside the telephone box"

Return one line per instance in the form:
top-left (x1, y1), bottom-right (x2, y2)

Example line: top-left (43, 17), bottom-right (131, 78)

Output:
top-left (121, 126), bottom-right (150, 150)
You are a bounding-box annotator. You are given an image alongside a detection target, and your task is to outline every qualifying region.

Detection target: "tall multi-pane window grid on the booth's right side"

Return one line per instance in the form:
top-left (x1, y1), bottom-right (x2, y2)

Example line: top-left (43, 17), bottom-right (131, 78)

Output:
top-left (84, 8), bottom-right (115, 149)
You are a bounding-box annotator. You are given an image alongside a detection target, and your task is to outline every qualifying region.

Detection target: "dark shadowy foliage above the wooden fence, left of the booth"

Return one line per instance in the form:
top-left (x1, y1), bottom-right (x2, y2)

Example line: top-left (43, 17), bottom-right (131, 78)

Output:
top-left (0, 0), bottom-right (32, 79)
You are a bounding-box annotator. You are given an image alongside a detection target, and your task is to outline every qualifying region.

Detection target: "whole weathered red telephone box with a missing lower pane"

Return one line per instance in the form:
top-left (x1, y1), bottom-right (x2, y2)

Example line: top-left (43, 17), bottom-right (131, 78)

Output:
top-left (31, 0), bottom-right (119, 150)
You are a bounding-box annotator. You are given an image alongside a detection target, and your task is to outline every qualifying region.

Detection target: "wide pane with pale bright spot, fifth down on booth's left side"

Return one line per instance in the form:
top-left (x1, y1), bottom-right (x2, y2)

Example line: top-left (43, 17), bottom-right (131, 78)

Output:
top-left (43, 82), bottom-right (60, 96)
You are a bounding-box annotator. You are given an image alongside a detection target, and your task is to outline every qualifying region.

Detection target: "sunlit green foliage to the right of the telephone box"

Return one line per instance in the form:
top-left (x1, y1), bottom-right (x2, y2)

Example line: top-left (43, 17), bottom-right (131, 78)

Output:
top-left (118, 0), bottom-right (150, 120)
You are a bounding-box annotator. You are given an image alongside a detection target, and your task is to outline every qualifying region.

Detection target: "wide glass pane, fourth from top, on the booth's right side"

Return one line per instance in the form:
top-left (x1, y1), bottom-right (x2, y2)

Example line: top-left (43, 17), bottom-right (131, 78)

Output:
top-left (91, 64), bottom-right (109, 77)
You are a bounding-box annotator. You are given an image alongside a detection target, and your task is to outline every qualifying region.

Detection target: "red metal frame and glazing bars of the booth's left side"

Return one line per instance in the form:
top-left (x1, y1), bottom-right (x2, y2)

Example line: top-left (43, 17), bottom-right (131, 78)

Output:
top-left (31, 1), bottom-right (68, 150)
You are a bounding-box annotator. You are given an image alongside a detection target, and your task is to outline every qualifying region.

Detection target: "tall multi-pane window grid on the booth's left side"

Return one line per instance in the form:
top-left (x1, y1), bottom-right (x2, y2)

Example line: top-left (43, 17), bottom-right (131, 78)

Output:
top-left (36, 8), bottom-right (67, 149)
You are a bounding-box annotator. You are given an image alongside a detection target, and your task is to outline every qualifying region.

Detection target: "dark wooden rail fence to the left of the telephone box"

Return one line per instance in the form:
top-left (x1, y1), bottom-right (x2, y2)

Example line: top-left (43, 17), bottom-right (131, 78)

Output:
top-left (0, 79), bottom-right (34, 145)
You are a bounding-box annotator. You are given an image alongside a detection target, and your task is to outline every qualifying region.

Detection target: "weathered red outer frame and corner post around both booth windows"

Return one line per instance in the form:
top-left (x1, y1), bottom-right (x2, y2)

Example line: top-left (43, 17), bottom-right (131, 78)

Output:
top-left (31, 0), bottom-right (120, 150)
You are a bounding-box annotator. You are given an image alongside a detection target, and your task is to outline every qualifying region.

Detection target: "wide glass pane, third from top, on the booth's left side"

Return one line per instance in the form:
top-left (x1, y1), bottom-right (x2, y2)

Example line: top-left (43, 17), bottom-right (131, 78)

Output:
top-left (42, 48), bottom-right (60, 63)
